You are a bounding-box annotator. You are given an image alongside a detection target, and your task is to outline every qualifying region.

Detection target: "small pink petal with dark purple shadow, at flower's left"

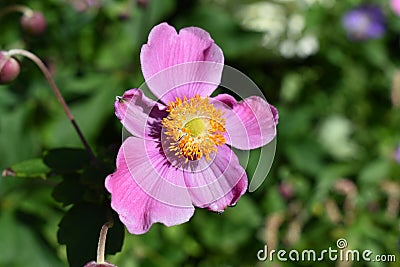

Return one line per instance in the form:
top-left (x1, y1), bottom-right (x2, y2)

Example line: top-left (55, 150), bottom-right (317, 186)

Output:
top-left (114, 89), bottom-right (168, 138)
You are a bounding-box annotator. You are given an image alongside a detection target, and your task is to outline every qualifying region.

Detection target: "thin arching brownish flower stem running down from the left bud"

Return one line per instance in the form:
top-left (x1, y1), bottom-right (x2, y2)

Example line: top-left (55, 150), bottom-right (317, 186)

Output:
top-left (7, 49), bottom-right (96, 160)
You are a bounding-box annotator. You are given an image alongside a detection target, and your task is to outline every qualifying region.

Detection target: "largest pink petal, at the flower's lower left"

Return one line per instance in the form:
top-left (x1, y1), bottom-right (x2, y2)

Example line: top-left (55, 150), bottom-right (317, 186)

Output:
top-left (105, 137), bottom-right (194, 234)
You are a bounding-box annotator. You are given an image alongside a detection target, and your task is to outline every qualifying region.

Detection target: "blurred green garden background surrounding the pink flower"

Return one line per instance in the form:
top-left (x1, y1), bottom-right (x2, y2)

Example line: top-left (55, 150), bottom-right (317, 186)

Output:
top-left (0, 0), bottom-right (400, 267)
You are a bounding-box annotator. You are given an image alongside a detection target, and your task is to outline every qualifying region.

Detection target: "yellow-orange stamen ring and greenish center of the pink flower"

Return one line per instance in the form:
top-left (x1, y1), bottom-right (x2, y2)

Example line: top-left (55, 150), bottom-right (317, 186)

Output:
top-left (162, 95), bottom-right (226, 162)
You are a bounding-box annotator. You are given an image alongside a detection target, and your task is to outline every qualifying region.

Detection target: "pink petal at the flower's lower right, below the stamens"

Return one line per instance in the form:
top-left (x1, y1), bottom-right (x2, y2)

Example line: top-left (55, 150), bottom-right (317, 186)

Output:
top-left (185, 145), bottom-right (247, 212)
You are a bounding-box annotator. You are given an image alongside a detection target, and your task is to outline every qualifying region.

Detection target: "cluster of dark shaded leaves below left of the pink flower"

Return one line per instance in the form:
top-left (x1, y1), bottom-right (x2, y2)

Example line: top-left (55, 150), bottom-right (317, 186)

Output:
top-left (44, 148), bottom-right (124, 267)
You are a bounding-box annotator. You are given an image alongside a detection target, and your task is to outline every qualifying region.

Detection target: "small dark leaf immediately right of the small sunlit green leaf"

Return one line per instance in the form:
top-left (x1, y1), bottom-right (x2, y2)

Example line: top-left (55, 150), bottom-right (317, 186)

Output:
top-left (44, 148), bottom-right (90, 172)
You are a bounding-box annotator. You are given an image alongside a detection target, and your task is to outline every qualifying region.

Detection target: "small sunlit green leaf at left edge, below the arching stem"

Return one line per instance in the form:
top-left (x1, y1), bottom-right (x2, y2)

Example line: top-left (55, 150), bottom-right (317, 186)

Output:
top-left (3, 158), bottom-right (50, 179)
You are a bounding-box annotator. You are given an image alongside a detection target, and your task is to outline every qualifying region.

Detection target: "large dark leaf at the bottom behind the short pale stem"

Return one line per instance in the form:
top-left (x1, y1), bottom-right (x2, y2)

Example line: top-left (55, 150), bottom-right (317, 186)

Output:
top-left (57, 203), bottom-right (124, 267)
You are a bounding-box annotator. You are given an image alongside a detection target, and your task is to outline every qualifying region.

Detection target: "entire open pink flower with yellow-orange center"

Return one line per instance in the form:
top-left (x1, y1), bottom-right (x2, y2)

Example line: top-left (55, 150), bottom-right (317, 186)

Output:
top-left (105, 23), bottom-right (278, 234)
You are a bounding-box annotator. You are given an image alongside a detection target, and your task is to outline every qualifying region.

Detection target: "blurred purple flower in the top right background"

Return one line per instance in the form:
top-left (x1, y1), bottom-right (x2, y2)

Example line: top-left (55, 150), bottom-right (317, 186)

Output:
top-left (342, 5), bottom-right (385, 41)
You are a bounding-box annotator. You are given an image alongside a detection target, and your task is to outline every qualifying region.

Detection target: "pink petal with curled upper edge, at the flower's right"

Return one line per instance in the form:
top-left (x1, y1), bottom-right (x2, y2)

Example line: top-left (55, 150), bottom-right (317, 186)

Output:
top-left (213, 94), bottom-right (279, 150)
